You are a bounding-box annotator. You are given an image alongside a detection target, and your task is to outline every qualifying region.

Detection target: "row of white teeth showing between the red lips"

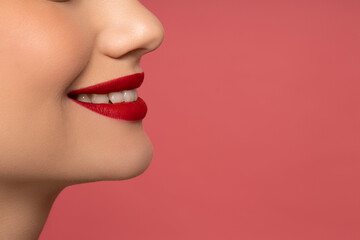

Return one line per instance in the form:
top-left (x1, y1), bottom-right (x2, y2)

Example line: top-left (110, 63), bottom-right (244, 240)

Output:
top-left (76, 89), bottom-right (138, 104)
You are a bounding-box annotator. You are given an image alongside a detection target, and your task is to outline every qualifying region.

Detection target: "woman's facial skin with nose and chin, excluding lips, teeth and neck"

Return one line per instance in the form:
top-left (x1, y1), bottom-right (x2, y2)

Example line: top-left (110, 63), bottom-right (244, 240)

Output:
top-left (0, 0), bottom-right (164, 181)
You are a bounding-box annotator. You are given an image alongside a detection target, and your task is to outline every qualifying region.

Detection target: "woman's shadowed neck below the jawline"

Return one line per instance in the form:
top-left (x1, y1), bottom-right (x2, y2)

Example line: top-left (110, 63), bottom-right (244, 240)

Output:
top-left (0, 181), bottom-right (65, 240)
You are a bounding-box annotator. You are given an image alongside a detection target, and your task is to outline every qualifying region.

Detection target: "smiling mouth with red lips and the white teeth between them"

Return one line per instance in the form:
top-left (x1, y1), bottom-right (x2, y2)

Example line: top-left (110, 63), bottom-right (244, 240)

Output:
top-left (67, 72), bottom-right (147, 121)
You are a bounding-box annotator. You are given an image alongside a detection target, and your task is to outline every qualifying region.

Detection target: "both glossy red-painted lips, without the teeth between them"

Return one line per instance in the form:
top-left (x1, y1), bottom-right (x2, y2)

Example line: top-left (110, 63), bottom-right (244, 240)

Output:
top-left (68, 73), bottom-right (147, 121)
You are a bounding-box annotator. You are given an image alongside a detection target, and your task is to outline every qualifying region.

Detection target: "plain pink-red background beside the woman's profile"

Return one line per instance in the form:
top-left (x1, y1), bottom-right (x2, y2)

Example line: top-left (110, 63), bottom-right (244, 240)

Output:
top-left (40, 0), bottom-right (360, 240)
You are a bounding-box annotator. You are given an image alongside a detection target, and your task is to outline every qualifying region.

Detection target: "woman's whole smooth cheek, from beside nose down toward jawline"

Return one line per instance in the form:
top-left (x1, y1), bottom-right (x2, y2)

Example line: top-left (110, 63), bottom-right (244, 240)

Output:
top-left (0, 0), bottom-right (92, 176)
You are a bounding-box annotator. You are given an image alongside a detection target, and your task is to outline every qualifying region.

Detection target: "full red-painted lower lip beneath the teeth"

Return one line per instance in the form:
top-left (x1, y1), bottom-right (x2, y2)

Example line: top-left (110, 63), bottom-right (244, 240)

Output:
top-left (70, 97), bottom-right (147, 121)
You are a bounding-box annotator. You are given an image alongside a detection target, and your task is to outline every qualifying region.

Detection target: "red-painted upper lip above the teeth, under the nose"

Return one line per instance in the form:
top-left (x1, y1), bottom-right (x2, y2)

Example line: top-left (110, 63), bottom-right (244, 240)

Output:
top-left (68, 72), bottom-right (144, 97)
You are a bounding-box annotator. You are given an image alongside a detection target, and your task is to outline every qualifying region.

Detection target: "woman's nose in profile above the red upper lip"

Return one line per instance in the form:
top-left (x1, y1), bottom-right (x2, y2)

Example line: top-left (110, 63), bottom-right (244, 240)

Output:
top-left (95, 0), bottom-right (164, 58)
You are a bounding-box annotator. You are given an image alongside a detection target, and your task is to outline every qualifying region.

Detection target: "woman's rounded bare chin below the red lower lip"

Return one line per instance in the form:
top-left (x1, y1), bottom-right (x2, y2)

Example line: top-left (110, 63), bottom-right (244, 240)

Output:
top-left (58, 134), bottom-right (154, 184)
